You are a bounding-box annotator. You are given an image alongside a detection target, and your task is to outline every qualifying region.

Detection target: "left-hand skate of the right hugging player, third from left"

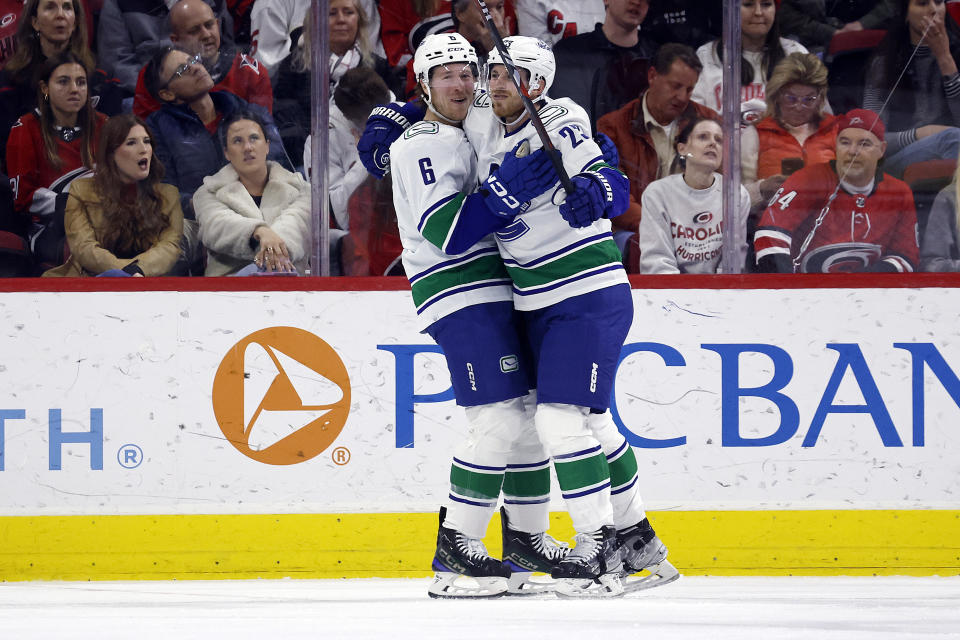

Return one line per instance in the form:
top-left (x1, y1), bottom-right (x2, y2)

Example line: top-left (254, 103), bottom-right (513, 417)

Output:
top-left (550, 526), bottom-right (623, 598)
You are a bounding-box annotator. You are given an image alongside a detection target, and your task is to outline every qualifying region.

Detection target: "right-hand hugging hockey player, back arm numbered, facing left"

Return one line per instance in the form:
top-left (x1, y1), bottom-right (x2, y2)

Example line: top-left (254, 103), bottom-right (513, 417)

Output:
top-left (465, 36), bottom-right (679, 596)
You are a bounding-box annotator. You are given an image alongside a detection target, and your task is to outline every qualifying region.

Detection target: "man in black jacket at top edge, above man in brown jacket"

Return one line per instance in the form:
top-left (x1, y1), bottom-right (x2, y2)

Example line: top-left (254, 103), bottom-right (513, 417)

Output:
top-left (550, 0), bottom-right (657, 130)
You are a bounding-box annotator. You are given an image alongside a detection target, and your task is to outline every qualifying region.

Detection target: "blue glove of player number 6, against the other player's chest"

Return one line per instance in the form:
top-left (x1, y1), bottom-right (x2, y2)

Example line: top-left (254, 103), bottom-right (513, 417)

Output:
top-left (480, 141), bottom-right (560, 217)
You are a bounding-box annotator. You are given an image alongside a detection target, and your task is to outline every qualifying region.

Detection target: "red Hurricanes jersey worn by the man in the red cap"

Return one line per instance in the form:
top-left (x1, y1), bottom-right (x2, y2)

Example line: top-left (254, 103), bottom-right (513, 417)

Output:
top-left (754, 162), bottom-right (919, 273)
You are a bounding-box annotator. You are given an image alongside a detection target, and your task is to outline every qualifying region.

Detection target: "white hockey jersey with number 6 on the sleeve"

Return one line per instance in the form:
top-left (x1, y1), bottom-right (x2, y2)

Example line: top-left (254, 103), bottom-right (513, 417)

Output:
top-left (390, 120), bottom-right (511, 330)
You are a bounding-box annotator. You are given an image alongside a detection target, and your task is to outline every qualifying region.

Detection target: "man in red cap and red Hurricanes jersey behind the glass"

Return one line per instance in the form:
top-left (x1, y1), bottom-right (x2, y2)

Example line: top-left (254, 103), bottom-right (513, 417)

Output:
top-left (754, 109), bottom-right (918, 273)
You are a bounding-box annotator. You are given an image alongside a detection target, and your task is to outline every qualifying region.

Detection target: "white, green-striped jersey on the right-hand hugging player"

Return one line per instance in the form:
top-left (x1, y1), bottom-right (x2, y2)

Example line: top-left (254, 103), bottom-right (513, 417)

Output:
top-left (464, 96), bottom-right (627, 311)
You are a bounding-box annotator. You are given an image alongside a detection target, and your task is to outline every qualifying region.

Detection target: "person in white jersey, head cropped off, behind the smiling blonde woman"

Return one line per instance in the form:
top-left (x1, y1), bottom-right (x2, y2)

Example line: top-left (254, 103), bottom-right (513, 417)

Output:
top-left (250, 0), bottom-right (383, 80)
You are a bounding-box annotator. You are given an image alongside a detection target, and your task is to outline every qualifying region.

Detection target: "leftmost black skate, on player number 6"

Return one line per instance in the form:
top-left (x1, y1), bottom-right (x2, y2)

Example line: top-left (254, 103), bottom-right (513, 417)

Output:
top-left (427, 508), bottom-right (510, 598)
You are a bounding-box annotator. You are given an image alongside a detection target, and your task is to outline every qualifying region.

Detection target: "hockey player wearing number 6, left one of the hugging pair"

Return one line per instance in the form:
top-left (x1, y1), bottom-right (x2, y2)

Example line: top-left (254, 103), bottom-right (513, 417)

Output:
top-left (390, 34), bottom-right (567, 597)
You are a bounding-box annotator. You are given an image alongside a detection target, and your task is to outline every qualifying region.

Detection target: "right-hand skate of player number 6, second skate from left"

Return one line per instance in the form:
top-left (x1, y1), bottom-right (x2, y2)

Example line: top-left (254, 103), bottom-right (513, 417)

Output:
top-left (500, 507), bottom-right (570, 596)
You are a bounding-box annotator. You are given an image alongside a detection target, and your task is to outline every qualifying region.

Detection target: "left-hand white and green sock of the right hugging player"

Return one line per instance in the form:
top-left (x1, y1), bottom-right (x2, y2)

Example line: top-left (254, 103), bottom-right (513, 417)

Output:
top-left (536, 403), bottom-right (613, 533)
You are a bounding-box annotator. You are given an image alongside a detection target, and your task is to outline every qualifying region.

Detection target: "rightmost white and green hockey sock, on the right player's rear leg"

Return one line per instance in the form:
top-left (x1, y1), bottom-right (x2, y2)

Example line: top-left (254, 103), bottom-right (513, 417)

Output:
top-left (587, 411), bottom-right (646, 529)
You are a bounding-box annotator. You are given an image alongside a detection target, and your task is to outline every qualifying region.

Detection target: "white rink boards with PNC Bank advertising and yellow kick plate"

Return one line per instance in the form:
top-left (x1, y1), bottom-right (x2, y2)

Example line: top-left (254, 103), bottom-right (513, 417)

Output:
top-left (0, 276), bottom-right (960, 580)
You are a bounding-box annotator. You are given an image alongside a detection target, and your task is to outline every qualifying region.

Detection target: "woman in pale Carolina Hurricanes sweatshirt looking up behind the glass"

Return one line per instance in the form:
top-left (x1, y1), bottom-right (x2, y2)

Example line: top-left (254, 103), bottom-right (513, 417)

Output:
top-left (637, 118), bottom-right (750, 274)
